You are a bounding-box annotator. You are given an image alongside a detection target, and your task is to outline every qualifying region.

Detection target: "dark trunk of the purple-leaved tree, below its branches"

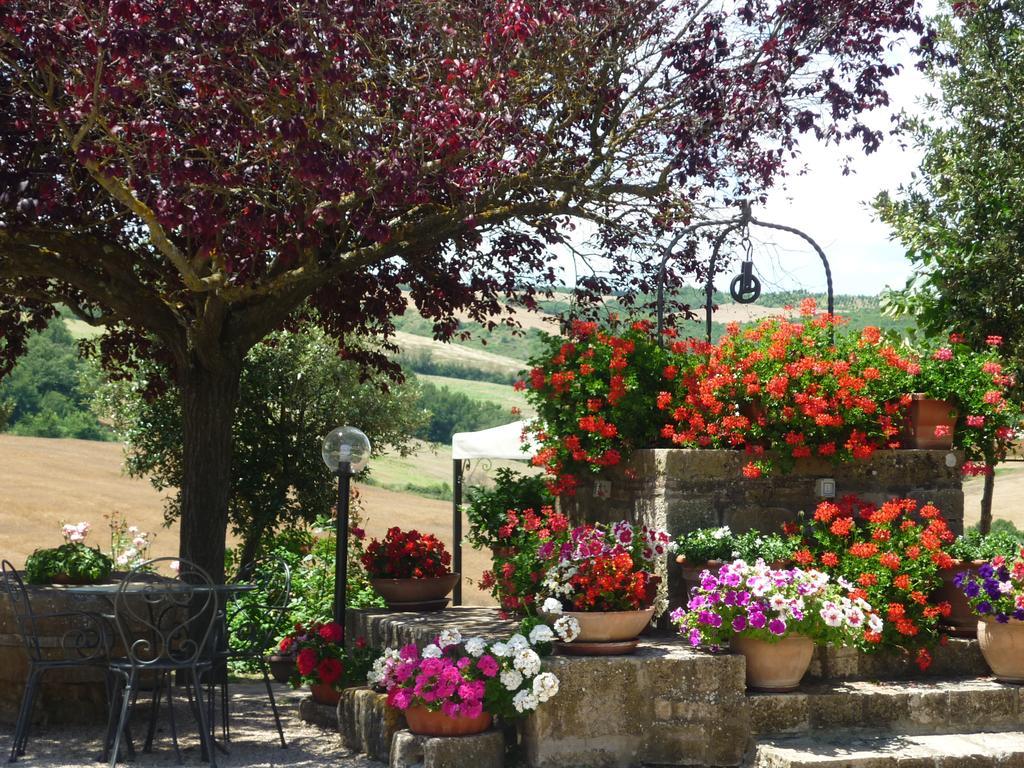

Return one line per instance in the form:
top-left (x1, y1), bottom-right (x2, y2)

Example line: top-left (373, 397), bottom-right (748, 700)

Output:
top-left (179, 365), bottom-right (242, 584)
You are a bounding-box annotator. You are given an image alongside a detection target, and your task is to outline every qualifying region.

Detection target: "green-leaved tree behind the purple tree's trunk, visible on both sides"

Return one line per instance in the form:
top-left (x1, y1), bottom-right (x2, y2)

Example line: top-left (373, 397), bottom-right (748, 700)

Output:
top-left (95, 325), bottom-right (426, 565)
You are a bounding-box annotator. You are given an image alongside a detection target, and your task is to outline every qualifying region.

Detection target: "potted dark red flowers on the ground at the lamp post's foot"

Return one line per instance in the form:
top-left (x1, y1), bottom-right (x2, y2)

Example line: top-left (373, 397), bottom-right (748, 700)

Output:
top-left (282, 622), bottom-right (374, 705)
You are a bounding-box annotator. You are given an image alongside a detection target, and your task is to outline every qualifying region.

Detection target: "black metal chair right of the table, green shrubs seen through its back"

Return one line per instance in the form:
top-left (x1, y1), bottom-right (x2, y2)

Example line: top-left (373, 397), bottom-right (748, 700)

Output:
top-left (207, 557), bottom-right (292, 749)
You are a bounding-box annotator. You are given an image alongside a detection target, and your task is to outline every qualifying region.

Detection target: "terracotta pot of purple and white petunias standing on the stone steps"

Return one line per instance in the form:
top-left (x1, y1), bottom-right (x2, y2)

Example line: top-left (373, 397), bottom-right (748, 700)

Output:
top-left (672, 560), bottom-right (884, 691)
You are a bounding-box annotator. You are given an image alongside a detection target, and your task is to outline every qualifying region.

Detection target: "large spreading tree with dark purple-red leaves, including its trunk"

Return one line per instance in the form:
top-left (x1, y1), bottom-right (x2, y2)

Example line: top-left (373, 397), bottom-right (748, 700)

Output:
top-left (0, 0), bottom-right (922, 577)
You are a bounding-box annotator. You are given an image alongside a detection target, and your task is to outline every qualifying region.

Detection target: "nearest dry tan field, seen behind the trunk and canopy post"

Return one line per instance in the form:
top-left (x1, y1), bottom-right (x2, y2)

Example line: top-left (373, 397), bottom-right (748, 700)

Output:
top-left (0, 434), bottom-right (1024, 604)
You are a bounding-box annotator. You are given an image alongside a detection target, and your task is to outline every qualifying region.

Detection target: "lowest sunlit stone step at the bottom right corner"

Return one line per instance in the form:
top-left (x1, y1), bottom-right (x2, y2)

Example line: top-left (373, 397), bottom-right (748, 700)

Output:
top-left (748, 730), bottom-right (1024, 768)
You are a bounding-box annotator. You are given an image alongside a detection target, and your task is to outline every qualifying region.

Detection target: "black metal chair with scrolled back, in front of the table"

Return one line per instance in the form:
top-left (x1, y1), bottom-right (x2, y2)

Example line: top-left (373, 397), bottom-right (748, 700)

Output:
top-left (106, 557), bottom-right (223, 768)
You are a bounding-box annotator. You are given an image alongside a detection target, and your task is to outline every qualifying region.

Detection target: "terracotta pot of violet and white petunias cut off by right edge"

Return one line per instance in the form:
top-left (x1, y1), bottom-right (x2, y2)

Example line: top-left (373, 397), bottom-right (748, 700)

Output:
top-left (957, 547), bottom-right (1024, 683)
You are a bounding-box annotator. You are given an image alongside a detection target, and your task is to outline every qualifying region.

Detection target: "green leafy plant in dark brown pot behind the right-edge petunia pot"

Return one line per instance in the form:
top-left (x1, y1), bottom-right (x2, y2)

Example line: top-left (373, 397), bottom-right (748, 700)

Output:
top-left (932, 529), bottom-right (1022, 637)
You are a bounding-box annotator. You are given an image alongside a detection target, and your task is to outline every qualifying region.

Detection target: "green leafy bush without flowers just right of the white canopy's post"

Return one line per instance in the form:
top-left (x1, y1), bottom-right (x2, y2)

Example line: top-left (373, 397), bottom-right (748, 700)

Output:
top-left (466, 467), bottom-right (554, 549)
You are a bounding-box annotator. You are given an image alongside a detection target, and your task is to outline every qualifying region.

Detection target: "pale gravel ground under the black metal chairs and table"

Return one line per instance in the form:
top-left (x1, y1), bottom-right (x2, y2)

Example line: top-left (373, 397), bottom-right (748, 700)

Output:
top-left (0, 683), bottom-right (384, 768)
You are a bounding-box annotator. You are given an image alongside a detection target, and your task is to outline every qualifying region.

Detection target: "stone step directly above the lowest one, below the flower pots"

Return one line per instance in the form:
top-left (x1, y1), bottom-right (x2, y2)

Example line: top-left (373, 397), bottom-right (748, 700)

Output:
top-left (746, 677), bottom-right (1024, 735)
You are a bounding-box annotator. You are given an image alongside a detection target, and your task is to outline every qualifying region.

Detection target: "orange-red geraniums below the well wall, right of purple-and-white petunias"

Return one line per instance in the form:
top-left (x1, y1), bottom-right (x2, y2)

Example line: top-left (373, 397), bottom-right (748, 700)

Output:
top-left (791, 496), bottom-right (954, 669)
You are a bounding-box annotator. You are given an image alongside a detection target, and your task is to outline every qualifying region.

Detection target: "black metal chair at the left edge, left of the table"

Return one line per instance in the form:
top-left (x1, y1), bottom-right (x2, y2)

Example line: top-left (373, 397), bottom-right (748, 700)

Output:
top-left (2, 560), bottom-right (111, 763)
